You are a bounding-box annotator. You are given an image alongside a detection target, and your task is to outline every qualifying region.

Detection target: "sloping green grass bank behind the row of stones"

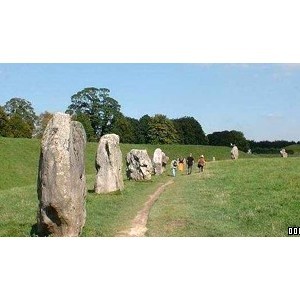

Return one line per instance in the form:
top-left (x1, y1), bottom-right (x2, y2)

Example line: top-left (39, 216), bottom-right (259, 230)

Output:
top-left (0, 137), bottom-right (243, 190)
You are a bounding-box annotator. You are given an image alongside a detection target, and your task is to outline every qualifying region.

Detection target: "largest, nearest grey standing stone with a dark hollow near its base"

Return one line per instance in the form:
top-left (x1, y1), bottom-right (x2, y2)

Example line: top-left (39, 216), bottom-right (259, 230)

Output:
top-left (37, 113), bottom-right (86, 236)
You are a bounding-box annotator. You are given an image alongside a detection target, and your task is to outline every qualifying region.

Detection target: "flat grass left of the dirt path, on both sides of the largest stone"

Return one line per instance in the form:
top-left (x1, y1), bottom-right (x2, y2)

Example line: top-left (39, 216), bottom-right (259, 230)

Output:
top-left (0, 175), bottom-right (173, 237)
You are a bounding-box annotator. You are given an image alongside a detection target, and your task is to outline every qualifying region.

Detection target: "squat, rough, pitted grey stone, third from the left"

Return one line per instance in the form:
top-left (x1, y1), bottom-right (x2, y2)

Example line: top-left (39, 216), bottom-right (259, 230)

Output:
top-left (126, 149), bottom-right (153, 181)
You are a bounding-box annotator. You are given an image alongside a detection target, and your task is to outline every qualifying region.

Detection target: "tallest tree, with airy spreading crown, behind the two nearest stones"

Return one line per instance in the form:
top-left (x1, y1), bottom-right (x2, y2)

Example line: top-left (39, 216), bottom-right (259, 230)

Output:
top-left (66, 87), bottom-right (121, 138)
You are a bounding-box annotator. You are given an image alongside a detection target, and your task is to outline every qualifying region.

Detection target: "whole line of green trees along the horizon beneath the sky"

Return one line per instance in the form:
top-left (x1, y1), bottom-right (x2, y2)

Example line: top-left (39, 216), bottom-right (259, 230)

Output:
top-left (0, 87), bottom-right (295, 152)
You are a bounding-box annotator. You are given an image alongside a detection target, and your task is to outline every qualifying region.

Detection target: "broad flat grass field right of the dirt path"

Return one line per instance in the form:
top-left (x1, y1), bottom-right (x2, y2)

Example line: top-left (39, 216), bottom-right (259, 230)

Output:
top-left (147, 158), bottom-right (300, 237)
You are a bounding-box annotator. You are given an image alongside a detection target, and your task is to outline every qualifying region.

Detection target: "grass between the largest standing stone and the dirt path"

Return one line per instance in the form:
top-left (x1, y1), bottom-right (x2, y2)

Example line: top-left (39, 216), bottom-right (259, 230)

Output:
top-left (81, 175), bottom-right (169, 237)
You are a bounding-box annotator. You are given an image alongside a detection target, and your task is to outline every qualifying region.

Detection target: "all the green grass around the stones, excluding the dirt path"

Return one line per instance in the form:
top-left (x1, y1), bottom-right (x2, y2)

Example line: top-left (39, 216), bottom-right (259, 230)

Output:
top-left (0, 138), bottom-right (300, 237)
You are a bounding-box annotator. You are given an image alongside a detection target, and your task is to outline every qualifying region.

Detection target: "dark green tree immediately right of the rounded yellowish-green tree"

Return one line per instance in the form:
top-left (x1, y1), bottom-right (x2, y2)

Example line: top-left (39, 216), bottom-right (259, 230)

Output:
top-left (172, 117), bottom-right (208, 145)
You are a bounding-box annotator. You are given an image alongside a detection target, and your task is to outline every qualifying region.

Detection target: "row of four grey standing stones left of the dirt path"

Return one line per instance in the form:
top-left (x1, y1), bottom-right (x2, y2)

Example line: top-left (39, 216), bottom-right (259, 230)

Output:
top-left (37, 113), bottom-right (169, 237)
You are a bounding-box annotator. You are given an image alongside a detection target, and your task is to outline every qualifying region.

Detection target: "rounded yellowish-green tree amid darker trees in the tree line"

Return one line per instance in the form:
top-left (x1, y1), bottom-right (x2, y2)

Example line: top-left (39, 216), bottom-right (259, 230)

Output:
top-left (148, 114), bottom-right (179, 144)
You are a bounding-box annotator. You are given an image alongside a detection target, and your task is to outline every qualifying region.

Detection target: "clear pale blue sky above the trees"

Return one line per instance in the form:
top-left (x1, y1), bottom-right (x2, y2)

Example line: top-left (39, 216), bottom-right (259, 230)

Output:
top-left (0, 63), bottom-right (300, 141)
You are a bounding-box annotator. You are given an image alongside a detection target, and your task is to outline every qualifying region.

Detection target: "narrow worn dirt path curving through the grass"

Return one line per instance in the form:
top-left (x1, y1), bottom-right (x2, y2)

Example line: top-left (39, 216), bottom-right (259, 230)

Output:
top-left (117, 180), bottom-right (174, 237)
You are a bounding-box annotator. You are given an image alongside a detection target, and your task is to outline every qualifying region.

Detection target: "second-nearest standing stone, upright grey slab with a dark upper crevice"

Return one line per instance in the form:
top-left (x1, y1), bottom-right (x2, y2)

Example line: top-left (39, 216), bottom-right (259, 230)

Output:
top-left (95, 134), bottom-right (124, 194)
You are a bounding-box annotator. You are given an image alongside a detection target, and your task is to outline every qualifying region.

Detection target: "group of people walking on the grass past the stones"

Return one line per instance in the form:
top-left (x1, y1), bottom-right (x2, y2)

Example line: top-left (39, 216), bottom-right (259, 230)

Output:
top-left (171, 153), bottom-right (206, 177)
